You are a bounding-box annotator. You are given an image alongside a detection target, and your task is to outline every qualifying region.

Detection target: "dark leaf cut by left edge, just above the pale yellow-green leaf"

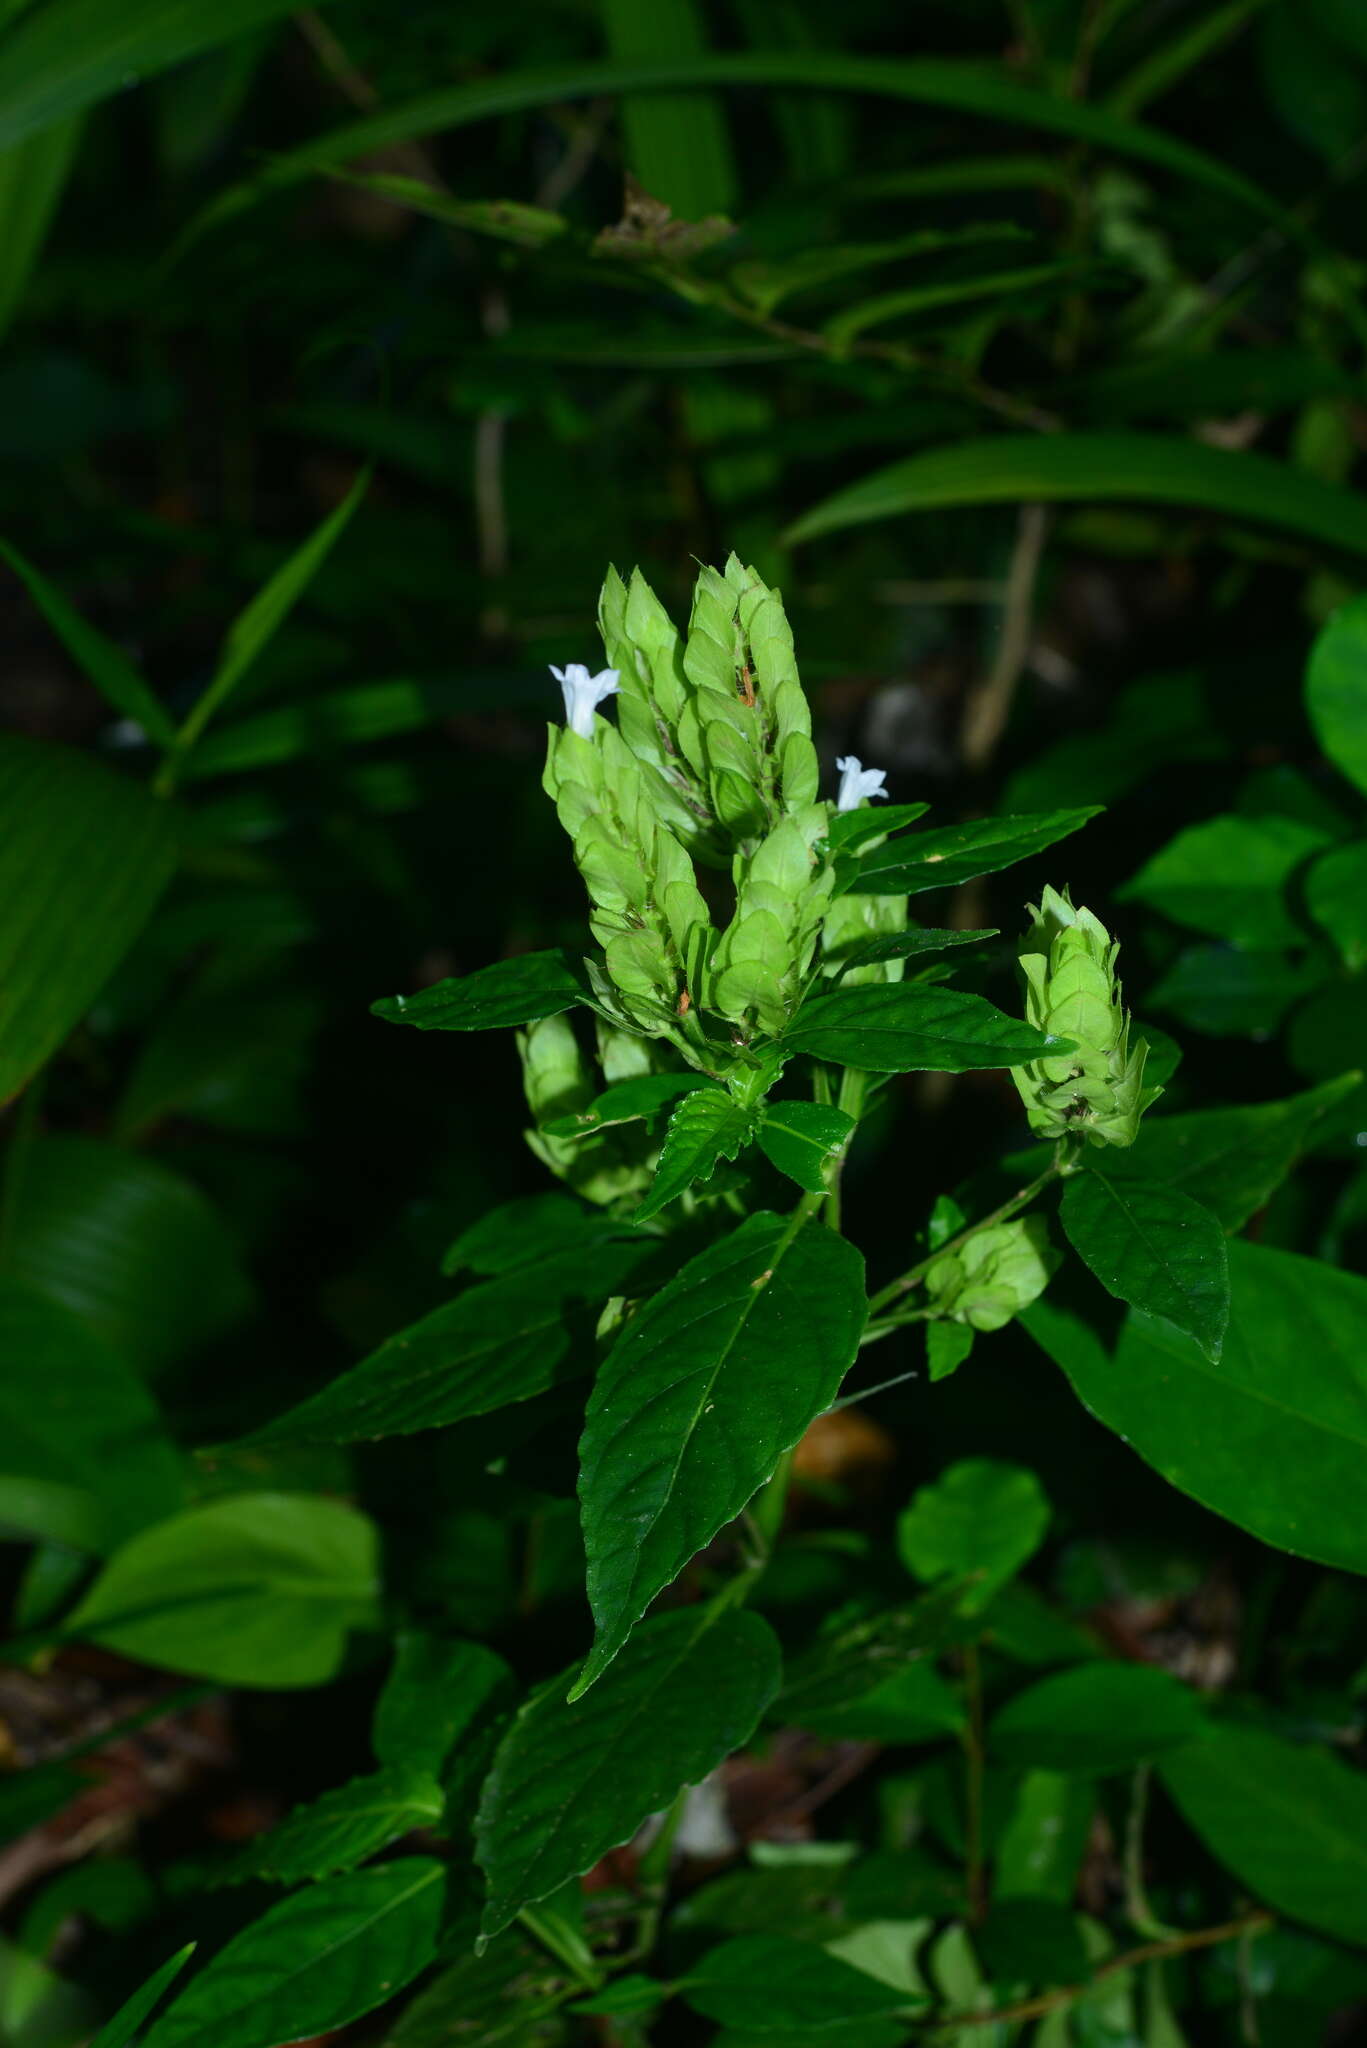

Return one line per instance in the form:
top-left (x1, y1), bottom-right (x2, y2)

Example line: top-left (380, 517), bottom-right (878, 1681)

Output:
top-left (0, 1280), bottom-right (184, 1552)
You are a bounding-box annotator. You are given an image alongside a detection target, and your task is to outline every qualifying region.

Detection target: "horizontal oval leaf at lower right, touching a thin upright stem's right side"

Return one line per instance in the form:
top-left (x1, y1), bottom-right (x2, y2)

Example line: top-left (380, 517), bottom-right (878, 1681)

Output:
top-left (988, 1657), bottom-right (1203, 1772)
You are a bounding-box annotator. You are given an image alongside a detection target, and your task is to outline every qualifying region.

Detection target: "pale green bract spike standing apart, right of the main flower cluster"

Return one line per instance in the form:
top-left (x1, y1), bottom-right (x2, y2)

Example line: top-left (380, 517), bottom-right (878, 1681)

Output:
top-left (1010, 889), bottom-right (1162, 1145)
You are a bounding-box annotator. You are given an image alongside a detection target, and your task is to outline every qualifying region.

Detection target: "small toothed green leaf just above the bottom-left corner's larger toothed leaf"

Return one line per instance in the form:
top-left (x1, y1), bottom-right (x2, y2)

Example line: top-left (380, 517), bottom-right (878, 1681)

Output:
top-left (230, 1761), bottom-right (445, 1884)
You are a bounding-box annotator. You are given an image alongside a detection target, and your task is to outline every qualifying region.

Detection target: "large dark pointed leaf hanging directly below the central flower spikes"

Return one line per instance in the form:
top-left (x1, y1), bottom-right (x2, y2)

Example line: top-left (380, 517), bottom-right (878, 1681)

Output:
top-left (576, 1210), bottom-right (867, 1692)
